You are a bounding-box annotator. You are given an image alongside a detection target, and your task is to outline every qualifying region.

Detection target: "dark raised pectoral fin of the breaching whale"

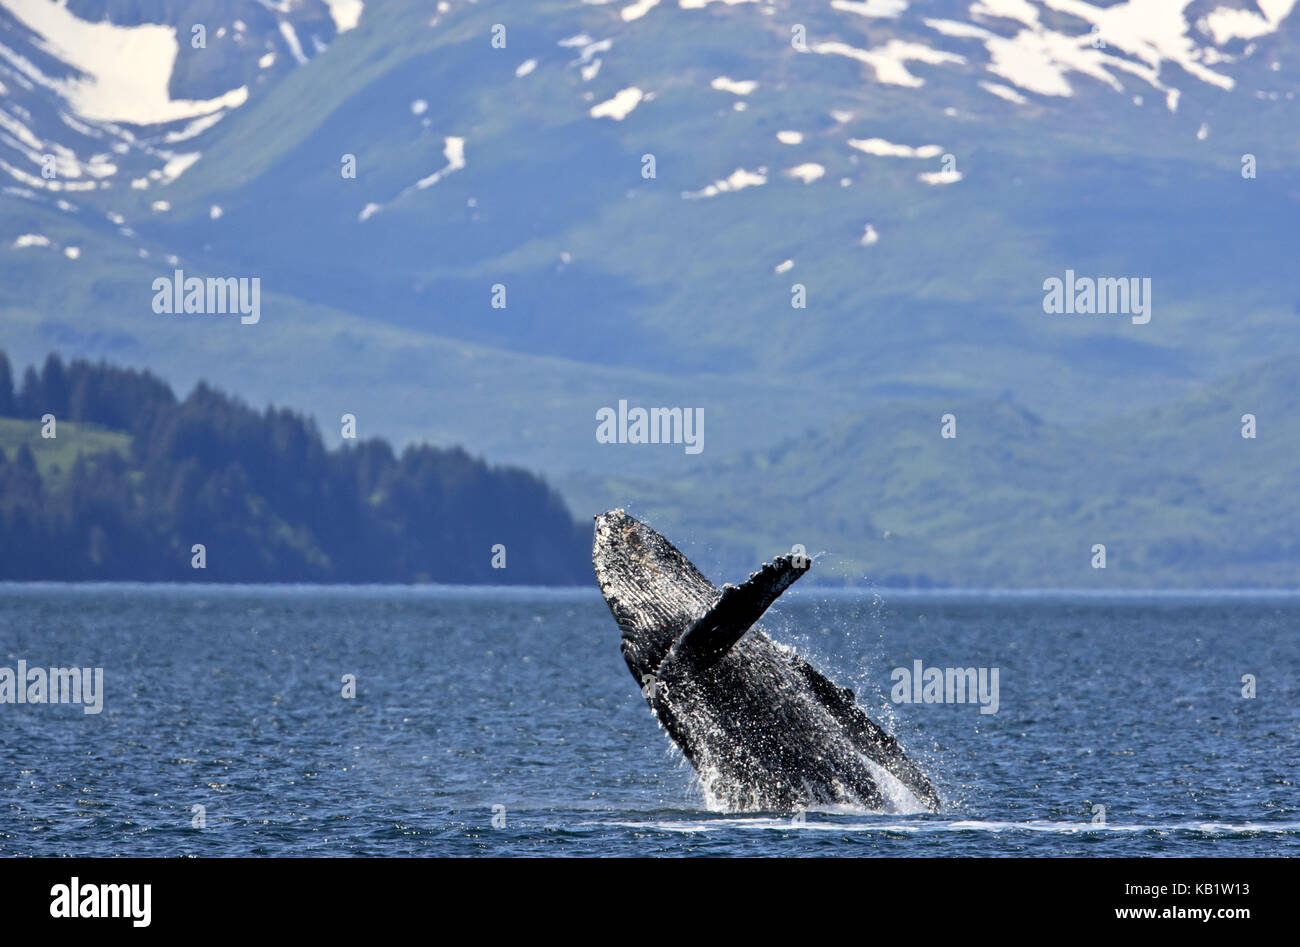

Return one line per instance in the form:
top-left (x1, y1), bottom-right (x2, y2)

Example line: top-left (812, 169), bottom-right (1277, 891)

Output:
top-left (664, 555), bottom-right (809, 673)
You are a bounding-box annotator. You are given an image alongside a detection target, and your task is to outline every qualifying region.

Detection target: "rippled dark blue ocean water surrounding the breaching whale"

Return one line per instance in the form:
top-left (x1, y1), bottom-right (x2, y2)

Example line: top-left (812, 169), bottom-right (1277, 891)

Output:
top-left (0, 585), bottom-right (1300, 856)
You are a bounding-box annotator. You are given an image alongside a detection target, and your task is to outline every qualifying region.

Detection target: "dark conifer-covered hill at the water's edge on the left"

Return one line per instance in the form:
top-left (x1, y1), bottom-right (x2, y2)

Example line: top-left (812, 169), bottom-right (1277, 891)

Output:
top-left (0, 353), bottom-right (590, 584)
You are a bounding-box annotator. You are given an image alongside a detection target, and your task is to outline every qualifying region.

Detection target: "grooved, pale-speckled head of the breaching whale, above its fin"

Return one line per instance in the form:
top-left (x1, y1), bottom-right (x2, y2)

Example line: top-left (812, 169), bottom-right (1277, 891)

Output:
top-left (592, 510), bottom-right (719, 683)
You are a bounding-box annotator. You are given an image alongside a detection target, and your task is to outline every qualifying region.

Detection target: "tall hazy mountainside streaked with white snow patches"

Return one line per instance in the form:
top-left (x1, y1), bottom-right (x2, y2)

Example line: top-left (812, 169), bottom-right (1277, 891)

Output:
top-left (0, 0), bottom-right (1300, 580)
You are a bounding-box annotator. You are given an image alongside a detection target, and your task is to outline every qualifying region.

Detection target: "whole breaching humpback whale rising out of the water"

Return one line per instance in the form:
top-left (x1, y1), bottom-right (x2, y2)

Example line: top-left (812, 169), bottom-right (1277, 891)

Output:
top-left (592, 510), bottom-right (940, 812)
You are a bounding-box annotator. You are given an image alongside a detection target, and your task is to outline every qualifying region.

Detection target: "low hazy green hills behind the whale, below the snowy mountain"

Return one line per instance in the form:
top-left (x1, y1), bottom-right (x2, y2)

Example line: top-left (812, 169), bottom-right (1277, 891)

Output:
top-left (566, 355), bottom-right (1300, 589)
